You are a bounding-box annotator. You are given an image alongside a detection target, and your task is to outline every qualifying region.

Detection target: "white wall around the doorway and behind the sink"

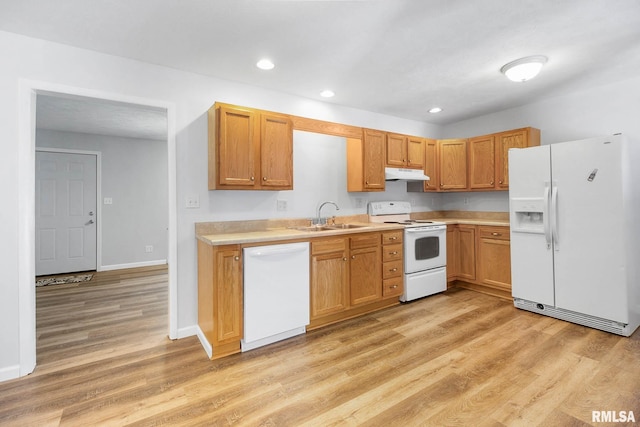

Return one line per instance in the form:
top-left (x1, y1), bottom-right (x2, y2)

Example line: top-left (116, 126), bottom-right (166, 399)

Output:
top-left (0, 28), bottom-right (440, 380)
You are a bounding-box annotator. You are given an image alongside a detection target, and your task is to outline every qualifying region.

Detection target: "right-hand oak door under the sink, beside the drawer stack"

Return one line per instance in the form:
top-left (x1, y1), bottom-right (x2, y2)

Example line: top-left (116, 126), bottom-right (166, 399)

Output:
top-left (349, 246), bottom-right (382, 305)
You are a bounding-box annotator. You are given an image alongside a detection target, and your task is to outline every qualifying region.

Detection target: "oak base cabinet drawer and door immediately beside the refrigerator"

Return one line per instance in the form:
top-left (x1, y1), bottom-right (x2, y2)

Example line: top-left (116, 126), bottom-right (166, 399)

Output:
top-left (478, 227), bottom-right (511, 291)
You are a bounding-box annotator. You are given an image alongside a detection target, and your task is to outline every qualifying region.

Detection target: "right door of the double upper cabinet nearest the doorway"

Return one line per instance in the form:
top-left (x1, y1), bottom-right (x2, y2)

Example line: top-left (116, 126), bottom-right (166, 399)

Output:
top-left (260, 113), bottom-right (293, 190)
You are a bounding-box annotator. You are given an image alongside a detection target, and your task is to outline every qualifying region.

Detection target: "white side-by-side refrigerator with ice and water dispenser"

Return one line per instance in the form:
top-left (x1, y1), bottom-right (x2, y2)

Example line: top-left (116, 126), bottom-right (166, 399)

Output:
top-left (509, 134), bottom-right (640, 336)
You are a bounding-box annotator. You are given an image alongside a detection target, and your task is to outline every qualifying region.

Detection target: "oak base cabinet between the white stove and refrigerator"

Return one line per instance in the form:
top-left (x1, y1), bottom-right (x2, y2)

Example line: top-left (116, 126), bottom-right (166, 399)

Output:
top-left (447, 224), bottom-right (511, 298)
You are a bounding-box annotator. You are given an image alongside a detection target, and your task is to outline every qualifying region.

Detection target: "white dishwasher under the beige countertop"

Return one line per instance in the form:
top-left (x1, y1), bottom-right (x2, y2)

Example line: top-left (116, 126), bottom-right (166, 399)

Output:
top-left (241, 242), bottom-right (309, 351)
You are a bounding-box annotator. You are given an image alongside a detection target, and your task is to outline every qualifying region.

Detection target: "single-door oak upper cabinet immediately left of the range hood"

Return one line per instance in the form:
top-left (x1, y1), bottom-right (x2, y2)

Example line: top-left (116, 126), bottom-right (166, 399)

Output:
top-left (347, 129), bottom-right (386, 191)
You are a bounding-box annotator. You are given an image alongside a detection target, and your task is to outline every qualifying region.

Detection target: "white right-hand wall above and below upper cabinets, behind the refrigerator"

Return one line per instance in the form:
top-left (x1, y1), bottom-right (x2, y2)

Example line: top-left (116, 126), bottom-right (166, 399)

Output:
top-left (442, 77), bottom-right (640, 212)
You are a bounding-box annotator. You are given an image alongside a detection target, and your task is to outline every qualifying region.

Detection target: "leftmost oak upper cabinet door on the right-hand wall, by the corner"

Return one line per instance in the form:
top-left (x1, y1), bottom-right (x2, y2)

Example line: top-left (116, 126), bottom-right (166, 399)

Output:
top-left (438, 139), bottom-right (467, 190)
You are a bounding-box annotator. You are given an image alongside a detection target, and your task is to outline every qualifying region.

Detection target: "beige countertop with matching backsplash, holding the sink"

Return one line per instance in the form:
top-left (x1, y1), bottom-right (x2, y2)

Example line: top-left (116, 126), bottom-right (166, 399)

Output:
top-left (196, 211), bottom-right (509, 246)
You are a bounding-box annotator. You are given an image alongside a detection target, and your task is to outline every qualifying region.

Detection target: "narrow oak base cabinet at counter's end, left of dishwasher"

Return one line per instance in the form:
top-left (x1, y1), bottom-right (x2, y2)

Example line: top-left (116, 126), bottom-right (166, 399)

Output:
top-left (198, 240), bottom-right (243, 359)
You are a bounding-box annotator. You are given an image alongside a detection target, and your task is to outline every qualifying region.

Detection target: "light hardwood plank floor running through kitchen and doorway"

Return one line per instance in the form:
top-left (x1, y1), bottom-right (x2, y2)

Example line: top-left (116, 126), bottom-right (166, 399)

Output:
top-left (0, 269), bottom-right (640, 426)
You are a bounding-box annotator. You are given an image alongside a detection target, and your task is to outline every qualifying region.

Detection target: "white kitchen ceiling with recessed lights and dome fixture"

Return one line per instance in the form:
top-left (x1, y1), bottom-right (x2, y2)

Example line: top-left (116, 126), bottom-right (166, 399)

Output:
top-left (0, 0), bottom-right (640, 137)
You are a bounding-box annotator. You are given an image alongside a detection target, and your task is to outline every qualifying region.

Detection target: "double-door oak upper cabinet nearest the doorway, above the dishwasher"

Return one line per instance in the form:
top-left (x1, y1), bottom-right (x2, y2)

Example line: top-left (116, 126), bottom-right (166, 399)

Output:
top-left (209, 104), bottom-right (293, 190)
